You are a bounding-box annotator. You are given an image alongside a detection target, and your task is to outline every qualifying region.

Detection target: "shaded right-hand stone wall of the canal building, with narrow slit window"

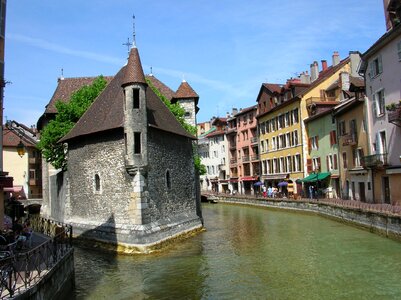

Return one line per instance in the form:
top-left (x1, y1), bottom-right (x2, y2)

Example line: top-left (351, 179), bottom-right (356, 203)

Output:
top-left (147, 129), bottom-right (196, 222)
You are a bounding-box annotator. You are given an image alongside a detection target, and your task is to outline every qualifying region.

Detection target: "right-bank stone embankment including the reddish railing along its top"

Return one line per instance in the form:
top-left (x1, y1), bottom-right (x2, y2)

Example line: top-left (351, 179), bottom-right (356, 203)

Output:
top-left (209, 194), bottom-right (401, 241)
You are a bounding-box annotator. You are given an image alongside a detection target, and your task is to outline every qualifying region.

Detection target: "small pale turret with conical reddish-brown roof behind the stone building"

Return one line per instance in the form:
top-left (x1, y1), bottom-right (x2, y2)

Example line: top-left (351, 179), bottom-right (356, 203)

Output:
top-left (171, 80), bottom-right (199, 126)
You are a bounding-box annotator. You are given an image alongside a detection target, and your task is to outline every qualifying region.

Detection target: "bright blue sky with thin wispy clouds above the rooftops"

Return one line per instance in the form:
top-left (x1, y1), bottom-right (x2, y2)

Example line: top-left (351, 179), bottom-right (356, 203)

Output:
top-left (3, 0), bottom-right (385, 126)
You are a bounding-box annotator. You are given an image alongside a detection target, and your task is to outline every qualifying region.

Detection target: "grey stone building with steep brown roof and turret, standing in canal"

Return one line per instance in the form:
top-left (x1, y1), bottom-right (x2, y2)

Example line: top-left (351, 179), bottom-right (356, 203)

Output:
top-left (42, 47), bottom-right (202, 252)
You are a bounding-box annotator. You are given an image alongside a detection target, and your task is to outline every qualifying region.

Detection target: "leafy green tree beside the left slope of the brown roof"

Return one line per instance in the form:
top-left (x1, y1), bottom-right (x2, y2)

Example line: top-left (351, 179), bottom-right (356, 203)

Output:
top-left (38, 76), bottom-right (107, 170)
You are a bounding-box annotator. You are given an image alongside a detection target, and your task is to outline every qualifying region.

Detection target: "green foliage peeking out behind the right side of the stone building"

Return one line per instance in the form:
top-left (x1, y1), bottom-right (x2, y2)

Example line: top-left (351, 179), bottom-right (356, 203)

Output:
top-left (146, 79), bottom-right (206, 175)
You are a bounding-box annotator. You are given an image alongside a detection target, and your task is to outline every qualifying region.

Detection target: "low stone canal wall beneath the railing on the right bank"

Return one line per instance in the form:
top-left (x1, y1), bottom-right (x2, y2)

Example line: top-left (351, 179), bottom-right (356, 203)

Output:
top-left (217, 195), bottom-right (401, 241)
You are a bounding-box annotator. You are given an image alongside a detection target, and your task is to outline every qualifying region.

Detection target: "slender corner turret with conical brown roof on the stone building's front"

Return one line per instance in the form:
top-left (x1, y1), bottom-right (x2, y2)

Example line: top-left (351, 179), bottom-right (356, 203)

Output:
top-left (121, 46), bottom-right (149, 225)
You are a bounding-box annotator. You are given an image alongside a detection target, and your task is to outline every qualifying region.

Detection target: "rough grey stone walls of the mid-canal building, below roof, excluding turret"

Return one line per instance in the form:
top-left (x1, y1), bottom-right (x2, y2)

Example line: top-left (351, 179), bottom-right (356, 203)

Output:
top-left (65, 128), bottom-right (202, 252)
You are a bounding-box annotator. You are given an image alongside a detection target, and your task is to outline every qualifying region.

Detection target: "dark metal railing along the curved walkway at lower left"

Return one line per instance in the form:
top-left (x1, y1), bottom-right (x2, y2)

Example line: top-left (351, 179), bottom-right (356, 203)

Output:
top-left (0, 218), bottom-right (72, 299)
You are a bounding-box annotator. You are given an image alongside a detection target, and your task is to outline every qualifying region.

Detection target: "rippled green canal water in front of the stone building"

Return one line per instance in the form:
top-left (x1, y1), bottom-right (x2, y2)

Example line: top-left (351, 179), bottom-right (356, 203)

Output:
top-left (74, 204), bottom-right (401, 300)
